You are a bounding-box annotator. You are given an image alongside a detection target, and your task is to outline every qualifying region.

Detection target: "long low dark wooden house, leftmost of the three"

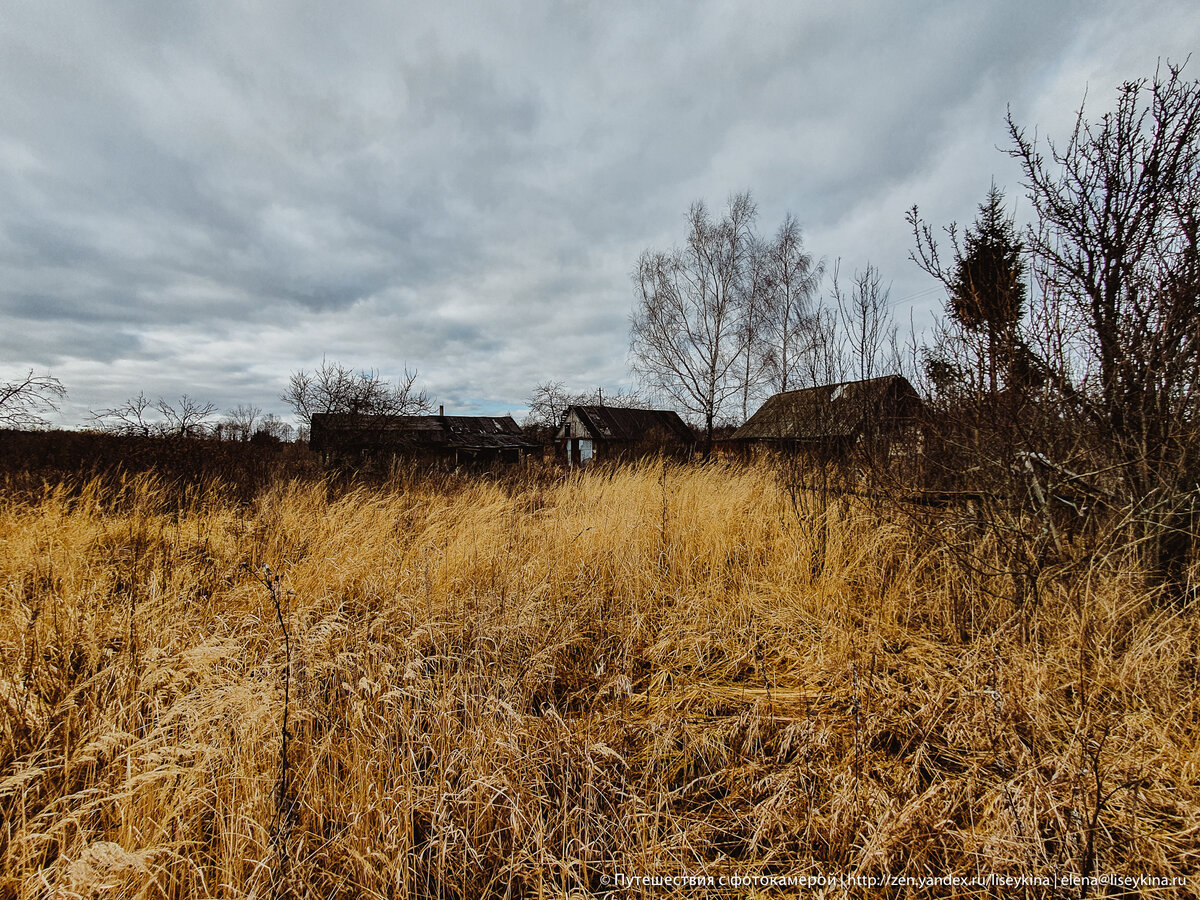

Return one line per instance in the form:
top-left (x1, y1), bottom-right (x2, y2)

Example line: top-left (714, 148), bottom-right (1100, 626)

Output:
top-left (308, 413), bottom-right (541, 467)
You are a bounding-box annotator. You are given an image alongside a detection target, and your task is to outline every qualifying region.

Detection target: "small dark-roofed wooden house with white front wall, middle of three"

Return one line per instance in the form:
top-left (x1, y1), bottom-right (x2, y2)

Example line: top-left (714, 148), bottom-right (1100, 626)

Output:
top-left (554, 406), bottom-right (696, 467)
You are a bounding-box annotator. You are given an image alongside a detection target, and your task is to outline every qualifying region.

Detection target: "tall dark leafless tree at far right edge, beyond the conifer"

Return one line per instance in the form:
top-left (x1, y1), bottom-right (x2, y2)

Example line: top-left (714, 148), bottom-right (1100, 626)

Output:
top-left (1008, 58), bottom-right (1200, 592)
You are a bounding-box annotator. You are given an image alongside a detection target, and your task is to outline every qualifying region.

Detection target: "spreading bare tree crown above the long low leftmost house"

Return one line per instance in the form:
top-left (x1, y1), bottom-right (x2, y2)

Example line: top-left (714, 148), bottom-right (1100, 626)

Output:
top-left (280, 360), bottom-right (433, 427)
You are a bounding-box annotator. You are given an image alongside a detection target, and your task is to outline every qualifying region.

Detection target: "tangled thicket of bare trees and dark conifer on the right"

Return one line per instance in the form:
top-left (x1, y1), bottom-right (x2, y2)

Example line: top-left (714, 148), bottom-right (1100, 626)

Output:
top-left (910, 65), bottom-right (1200, 600)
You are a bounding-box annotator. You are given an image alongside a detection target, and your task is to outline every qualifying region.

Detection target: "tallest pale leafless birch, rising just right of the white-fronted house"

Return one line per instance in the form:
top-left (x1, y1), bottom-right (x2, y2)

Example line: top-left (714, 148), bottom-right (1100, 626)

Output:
top-left (630, 192), bottom-right (757, 446)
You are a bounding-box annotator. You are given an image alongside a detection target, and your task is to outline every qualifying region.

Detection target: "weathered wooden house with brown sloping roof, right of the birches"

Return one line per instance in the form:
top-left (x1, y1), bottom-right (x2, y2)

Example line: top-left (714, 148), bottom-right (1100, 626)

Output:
top-left (731, 376), bottom-right (922, 460)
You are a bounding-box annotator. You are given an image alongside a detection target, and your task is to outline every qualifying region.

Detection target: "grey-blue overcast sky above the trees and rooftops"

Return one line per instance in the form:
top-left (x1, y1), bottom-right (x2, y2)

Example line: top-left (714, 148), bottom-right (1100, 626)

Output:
top-left (0, 0), bottom-right (1200, 425)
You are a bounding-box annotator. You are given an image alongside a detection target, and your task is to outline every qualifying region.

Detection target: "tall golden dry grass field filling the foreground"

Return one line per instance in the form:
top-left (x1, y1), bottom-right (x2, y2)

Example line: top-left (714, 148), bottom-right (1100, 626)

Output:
top-left (0, 463), bottom-right (1200, 898)
